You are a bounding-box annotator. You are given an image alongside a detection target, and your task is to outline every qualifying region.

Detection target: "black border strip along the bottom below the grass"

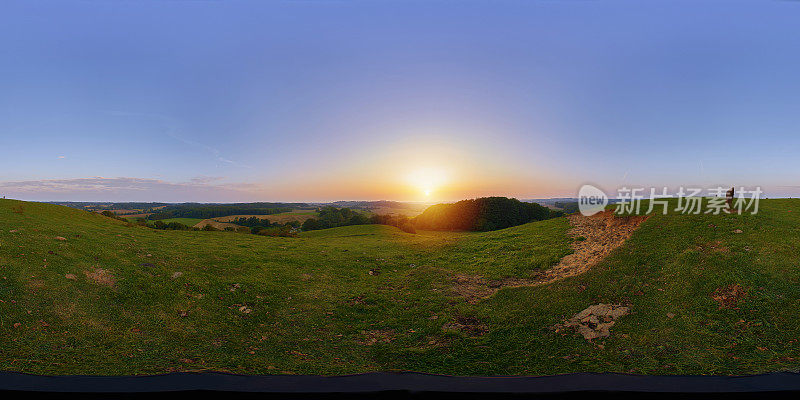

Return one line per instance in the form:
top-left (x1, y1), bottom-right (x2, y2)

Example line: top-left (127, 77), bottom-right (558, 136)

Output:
top-left (0, 372), bottom-right (800, 393)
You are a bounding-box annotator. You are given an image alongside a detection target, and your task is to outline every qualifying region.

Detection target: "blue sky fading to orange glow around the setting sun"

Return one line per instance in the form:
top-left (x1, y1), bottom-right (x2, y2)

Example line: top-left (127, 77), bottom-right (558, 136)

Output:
top-left (0, 0), bottom-right (800, 202)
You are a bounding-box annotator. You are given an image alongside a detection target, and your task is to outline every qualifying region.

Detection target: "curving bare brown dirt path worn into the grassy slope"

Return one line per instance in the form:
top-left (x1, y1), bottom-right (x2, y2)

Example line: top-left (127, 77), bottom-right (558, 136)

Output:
top-left (453, 211), bottom-right (647, 303)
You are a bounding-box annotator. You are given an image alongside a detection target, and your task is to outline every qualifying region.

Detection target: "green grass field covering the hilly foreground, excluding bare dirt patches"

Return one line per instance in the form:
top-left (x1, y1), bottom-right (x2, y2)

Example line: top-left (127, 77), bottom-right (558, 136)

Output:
top-left (0, 200), bottom-right (800, 375)
